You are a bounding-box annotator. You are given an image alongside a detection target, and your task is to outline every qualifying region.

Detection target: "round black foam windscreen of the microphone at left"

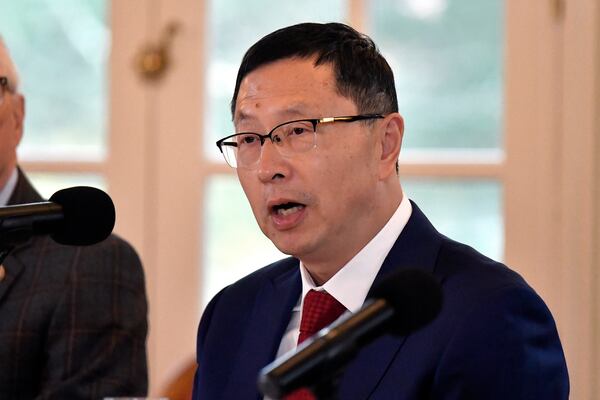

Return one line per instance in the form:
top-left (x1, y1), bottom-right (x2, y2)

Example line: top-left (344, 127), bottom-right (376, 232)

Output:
top-left (50, 186), bottom-right (115, 246)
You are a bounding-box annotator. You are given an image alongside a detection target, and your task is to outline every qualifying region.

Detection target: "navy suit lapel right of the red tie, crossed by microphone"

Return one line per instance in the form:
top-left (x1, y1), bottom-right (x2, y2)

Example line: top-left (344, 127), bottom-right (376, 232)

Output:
top-left (340, 203), bottom-right (441, 399)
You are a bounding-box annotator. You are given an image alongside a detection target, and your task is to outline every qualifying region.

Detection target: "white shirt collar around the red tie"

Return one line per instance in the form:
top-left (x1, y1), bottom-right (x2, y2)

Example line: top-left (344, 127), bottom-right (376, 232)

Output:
top-left (297, 195), bottom-right (412, 312)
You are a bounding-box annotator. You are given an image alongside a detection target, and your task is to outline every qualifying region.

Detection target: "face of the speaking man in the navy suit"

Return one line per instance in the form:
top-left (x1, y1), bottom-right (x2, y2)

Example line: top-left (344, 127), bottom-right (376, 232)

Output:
top-left (234, 58), bottom-right (381, 266)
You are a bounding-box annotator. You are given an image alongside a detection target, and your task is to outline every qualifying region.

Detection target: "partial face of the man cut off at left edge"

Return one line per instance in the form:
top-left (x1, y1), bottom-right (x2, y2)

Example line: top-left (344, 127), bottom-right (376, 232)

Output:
top-left (0, 70), bottom-right (24, 188)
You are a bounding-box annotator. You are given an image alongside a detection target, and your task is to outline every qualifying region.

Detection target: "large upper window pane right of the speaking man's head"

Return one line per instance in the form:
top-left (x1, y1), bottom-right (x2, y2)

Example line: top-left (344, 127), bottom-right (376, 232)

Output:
top-left (368, 0), bottom-right (504, 149)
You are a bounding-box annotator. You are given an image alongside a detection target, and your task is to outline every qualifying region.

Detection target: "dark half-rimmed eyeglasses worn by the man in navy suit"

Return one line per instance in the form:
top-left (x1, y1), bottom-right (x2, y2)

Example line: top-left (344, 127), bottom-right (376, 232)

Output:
top-left (217, 114), bottom-right (385, 168)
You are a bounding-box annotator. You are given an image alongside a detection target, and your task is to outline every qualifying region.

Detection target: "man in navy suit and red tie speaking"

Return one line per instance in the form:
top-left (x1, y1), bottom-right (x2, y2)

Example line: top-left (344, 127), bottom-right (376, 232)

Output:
top-left (194, 23), bottom-right (569, 400)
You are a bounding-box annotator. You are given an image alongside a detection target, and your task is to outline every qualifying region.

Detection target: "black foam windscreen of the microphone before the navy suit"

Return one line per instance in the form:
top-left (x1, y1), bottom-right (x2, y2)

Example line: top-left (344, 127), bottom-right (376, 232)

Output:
top-left (369, 269), bottom-right (442, 336)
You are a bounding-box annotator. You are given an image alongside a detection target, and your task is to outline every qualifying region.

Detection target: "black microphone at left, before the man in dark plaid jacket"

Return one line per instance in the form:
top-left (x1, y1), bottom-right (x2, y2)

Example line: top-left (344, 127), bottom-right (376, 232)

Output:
top-left (0, 186), bottom-right (115, 246)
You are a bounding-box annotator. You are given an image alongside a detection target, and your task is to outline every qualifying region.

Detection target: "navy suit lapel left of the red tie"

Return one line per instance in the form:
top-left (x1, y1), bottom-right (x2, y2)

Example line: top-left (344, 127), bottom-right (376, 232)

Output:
top-left (223, 259), bottom-right (302, 399)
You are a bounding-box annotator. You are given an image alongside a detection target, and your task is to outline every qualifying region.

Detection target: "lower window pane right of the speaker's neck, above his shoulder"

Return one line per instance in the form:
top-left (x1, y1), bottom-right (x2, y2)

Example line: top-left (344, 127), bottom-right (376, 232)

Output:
top-left (402, 178), bottom-right (504, 260)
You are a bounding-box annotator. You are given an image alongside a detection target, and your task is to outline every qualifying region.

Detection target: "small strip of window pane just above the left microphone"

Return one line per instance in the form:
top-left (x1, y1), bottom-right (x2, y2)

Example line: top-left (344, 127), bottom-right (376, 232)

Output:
top-left (27, 172), bottom-right (106, 199)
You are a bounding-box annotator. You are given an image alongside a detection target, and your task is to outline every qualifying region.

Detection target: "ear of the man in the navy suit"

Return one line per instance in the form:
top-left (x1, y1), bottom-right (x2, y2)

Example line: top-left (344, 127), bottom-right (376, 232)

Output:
top-left (379, 113), bottom-right (404, 179)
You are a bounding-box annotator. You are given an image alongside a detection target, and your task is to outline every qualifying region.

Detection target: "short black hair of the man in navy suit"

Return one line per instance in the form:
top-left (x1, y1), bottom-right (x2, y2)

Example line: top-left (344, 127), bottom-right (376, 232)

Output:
top-left (231, 23), bottom-right (398, 115)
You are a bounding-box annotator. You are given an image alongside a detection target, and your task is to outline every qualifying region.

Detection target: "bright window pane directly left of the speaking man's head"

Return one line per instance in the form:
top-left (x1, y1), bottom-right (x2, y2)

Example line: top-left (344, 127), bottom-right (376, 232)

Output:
top-left (204, 0), bottom-right (346, 161)
